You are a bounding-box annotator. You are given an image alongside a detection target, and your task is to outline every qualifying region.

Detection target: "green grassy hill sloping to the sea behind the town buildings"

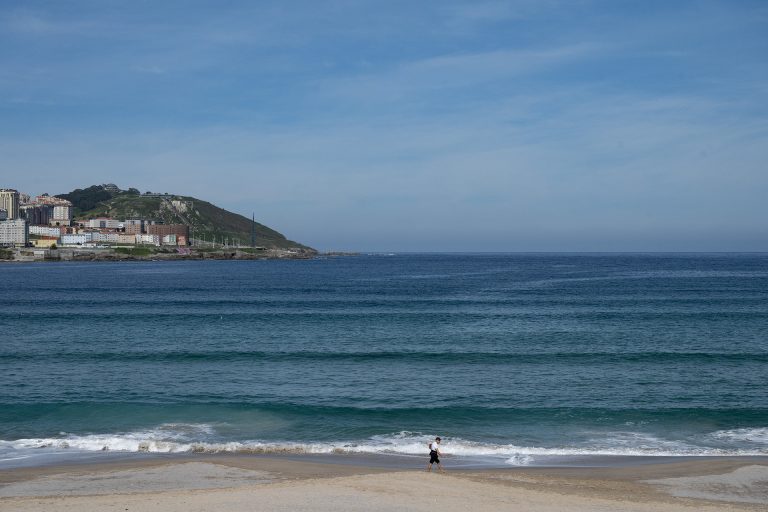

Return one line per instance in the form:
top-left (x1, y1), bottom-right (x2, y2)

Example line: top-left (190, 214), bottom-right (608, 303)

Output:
top-left (57, 184), bottom-right (313, 250)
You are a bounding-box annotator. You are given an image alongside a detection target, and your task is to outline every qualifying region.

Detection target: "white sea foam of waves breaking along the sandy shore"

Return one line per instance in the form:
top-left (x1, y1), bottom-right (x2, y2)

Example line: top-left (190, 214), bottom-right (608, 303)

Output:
top-left (0, 424), bottom-right (768, 465)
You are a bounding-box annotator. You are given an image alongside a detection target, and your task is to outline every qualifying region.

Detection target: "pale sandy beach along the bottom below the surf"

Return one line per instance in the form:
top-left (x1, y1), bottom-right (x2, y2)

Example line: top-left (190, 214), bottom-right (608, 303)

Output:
top-left (0, 456), bottom-right (768, 512)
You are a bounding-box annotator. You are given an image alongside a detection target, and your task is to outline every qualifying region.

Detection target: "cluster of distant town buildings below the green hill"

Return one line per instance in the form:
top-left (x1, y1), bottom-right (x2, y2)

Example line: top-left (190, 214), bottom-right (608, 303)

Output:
top-left (0, 185), bottom-right (190, 253)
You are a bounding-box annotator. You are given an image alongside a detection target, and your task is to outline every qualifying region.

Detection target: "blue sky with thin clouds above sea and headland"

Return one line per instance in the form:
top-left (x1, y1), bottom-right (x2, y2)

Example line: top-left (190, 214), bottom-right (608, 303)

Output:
top-left (0, 0), bottom-right (768, 252)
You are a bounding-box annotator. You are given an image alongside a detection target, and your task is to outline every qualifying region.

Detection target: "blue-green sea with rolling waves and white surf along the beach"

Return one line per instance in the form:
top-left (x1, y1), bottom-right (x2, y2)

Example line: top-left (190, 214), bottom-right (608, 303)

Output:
top-left (0, 253), bottom-right (768, 468)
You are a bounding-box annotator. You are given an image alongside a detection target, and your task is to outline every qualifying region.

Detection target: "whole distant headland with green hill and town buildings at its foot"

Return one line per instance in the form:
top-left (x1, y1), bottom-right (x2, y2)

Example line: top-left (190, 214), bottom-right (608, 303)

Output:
top-left (0, 183), bottom-right (317, 262)
